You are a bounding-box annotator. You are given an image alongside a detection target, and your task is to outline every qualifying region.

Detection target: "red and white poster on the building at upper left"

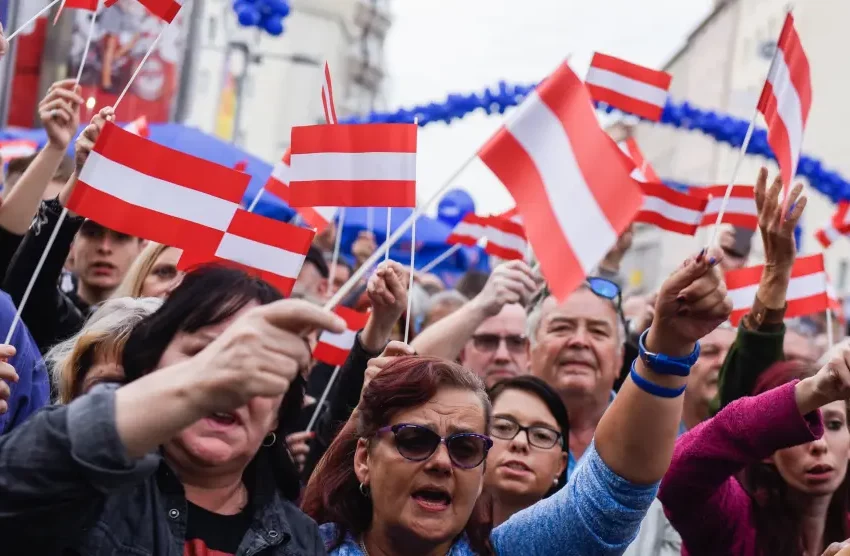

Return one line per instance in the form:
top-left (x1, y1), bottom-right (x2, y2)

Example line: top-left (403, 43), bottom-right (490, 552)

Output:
top-left (68, 0), bottom-right (191, 123)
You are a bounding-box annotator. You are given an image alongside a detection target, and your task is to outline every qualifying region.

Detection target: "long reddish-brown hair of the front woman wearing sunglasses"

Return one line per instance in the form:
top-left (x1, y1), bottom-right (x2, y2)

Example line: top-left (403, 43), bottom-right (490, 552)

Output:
top-left (301, 356), bottom-right (493, 555)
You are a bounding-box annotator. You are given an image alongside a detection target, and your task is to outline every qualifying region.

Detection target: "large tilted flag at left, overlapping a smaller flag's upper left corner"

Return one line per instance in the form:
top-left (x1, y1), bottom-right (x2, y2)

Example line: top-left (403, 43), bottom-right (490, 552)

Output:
top-left (68, 122), bottom-right (251, 249)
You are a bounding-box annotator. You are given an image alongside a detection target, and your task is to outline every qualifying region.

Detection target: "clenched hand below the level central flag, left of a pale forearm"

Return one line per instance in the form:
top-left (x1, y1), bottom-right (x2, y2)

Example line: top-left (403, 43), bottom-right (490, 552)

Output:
top-left (360, 261), bottom-right (410, 353)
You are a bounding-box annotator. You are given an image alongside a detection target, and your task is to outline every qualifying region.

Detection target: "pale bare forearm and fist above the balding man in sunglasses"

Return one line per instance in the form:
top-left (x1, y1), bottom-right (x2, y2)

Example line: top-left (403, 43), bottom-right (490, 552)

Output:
top-left (411, 261), bottom-right (536, 361)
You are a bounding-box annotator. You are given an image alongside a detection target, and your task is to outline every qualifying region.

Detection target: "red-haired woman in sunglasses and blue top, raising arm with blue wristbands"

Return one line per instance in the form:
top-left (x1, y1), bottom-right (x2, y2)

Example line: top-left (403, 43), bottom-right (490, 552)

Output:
top-left (302, 252), bottom-right (731, 556)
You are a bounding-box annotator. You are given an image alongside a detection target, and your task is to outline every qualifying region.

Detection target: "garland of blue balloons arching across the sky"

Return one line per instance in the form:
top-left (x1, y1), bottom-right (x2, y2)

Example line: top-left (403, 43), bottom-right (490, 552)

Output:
top-left (343, 81), bottom-right (850, 203)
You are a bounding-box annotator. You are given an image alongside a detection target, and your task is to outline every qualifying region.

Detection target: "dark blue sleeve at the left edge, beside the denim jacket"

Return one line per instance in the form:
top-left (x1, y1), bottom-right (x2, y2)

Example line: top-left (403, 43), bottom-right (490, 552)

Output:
top-left (0, 292), bottom-right (50, 434)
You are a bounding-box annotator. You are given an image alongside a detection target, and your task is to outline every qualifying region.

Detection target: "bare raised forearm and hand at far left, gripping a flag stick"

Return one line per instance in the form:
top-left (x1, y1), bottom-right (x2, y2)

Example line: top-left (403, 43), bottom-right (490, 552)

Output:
top-left (0, 79), bottom-right (83, 235)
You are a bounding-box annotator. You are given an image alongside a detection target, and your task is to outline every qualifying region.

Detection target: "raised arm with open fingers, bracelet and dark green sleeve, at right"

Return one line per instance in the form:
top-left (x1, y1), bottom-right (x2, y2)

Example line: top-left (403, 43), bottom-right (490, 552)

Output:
top-left (713, 168), bottom-right (806, 412)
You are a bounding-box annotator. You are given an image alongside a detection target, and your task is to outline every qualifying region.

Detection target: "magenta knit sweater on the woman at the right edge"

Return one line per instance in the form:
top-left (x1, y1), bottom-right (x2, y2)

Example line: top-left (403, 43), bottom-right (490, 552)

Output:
top-left (658, 381), bottom-right (823, 556)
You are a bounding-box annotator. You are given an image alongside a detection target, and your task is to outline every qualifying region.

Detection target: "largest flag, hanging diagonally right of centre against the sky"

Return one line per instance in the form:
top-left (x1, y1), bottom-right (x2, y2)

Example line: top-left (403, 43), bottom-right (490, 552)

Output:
top-left (478, 63), bottom-right (643, 300)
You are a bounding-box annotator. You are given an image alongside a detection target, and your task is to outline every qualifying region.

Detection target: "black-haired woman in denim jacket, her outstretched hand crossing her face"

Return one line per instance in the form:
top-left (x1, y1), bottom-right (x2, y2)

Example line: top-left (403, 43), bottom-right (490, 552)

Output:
top-left (0, 267), bottom-right (345, 556)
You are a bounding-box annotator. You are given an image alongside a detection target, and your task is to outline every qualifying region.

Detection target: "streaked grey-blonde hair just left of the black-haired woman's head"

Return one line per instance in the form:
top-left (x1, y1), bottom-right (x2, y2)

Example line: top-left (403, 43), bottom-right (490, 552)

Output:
top-left (44, 297), bottom-right (162, 404)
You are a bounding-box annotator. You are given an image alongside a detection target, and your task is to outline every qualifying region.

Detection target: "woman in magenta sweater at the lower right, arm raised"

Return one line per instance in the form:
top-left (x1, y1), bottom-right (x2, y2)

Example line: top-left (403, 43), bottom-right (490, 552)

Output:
top-left (658, 347), bottom-right (850, 556)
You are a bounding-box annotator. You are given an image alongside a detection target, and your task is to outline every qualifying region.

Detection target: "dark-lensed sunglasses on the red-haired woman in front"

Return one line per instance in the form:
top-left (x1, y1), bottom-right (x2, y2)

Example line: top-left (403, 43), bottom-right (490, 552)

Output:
top-left (375, 423), bottom-right (493, 469)
